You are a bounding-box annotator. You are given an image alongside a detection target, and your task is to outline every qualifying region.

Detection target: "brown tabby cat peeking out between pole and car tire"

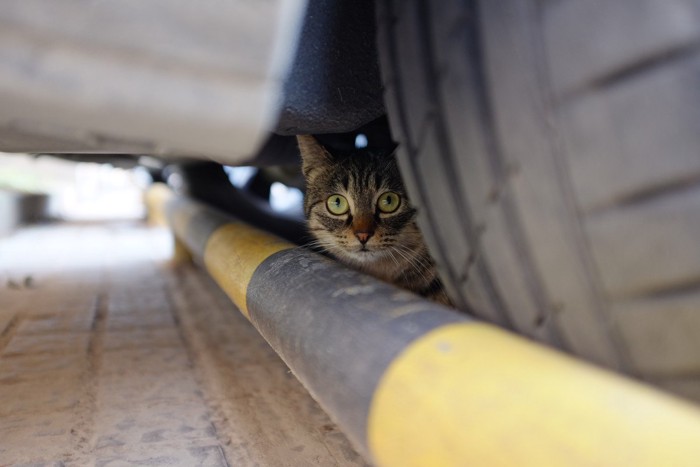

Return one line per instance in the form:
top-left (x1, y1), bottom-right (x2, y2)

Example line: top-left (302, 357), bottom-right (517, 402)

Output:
top-left (297, 135), bottom-right (451, 305)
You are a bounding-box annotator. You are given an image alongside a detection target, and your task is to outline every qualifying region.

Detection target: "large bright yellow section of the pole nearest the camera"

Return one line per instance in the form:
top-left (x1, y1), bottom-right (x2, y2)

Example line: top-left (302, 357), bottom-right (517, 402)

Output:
top-left (368, 323), bottom-right (700, 467)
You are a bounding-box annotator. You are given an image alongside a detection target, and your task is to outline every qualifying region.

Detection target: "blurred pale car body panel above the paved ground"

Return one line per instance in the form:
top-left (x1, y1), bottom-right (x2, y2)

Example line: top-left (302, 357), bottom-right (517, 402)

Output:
top-left (0, 0), bottom-right (306, 164)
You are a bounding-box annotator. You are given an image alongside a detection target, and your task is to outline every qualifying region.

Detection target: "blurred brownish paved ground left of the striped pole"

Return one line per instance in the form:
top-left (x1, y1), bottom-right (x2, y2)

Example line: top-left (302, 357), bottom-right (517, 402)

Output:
top-left (0, 223), bottom-right (365, 466)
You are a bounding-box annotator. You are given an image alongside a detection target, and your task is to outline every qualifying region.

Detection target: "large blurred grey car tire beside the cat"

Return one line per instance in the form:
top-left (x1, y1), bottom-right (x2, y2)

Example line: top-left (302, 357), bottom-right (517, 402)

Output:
top-left (377, 0), bottom-right (700, 400)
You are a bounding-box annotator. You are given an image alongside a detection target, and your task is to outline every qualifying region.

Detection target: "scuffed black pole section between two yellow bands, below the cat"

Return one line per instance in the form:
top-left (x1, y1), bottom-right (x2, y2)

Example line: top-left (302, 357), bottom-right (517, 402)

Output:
top-left (248, 249), bottom-right (467, 447)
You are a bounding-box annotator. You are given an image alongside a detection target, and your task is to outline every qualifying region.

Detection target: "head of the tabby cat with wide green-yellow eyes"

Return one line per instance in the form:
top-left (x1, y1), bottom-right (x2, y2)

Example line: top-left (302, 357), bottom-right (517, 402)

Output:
top-left (298, 136), bottom-right (422, 266)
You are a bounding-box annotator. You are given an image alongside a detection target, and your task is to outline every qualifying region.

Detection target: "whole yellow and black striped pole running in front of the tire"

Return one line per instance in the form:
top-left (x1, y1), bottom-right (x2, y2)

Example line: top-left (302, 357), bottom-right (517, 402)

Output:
top-left (156, 186), bottom-right (700, 467)
